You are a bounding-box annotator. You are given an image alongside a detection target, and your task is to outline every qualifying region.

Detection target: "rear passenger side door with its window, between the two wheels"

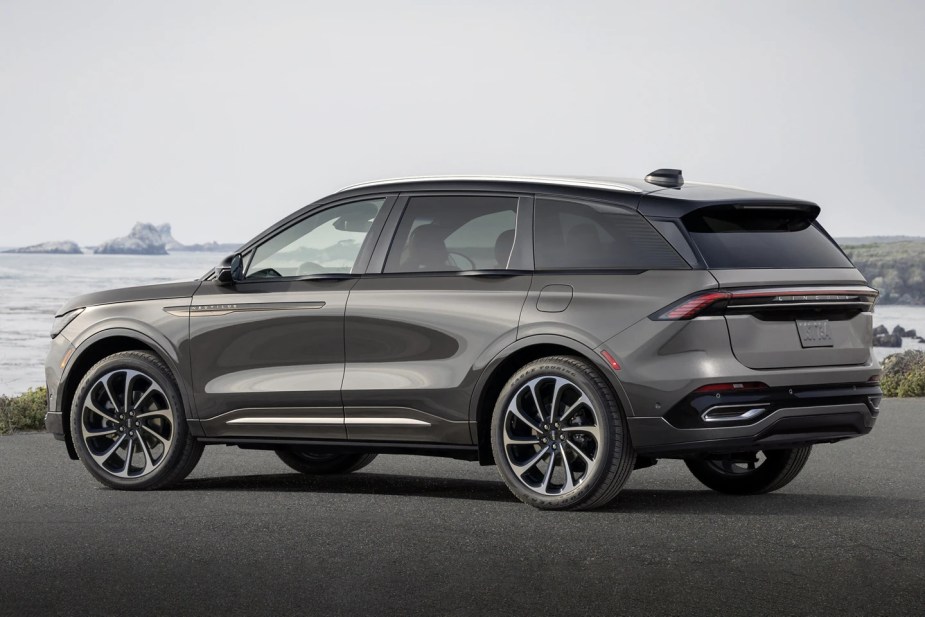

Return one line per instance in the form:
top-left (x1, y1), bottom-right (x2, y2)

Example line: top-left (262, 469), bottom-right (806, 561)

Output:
top-left (343, 193), bottom-right (533, 444)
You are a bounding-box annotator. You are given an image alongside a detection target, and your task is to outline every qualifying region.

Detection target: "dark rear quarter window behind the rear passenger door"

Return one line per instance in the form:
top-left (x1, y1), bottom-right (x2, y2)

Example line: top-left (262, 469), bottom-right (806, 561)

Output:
top-left (533, 198), bottom-right (690, 270)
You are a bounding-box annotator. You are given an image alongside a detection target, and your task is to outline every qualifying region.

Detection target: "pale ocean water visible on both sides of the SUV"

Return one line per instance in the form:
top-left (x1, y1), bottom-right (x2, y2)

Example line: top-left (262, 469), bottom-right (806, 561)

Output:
top-left (0, 253), bottom-right (925, 394)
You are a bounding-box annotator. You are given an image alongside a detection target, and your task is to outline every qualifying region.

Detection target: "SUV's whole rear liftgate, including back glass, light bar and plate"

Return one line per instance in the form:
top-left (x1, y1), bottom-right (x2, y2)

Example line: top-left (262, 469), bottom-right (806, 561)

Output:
top-left (683, 205), bottom-right (876, 369)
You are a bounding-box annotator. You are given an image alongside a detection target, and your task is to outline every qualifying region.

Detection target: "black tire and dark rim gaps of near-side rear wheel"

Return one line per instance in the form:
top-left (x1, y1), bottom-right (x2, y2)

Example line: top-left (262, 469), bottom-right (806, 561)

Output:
top-left (491, 356), bottom-right (636, 510)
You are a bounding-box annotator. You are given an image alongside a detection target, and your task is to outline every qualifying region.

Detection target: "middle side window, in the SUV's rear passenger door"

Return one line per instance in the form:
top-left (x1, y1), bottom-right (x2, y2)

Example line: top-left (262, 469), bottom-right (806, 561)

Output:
top-left (385, 195), bottom-right (517, 272)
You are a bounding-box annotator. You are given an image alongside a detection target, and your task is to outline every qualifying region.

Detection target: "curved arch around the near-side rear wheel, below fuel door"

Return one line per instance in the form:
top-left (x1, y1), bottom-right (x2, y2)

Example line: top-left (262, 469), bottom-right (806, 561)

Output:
top-left (469, 335), bottom-right (632, 465)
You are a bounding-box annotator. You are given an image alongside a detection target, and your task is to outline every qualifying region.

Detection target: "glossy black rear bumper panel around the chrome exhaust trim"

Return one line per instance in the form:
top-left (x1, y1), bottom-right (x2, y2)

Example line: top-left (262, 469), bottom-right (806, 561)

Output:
top-left (664, 383), bottom-right (883, 429)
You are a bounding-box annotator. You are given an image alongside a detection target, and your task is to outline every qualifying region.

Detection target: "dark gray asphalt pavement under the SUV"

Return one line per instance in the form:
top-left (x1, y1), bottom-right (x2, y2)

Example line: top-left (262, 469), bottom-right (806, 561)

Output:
top-left (0, 399), bottom-right (925, 617)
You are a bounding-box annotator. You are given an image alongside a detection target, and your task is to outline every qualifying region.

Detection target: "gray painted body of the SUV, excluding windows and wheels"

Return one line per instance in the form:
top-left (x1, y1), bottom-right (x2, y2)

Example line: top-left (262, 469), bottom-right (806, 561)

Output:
top-left (46, 176), bottom-right (879, 456)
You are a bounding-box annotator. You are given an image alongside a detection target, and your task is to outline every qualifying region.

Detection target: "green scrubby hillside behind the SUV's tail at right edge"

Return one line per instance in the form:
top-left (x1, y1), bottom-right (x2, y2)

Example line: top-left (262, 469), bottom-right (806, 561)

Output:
top-left (839, 238), bottom-right (925, 305)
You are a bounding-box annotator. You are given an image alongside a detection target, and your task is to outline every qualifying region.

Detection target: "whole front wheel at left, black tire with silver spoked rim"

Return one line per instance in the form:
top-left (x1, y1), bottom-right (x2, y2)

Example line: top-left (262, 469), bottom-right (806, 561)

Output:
top-left (71, 351), bottom-right (203, 490)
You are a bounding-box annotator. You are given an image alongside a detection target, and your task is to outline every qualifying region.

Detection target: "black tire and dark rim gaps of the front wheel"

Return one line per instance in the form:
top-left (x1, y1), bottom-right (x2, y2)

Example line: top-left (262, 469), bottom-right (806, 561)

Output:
top-left (70, 351), bottom-right (203, 490)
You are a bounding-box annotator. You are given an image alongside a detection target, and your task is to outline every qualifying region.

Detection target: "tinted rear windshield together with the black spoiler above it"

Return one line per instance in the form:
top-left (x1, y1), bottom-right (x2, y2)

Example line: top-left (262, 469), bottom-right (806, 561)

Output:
top-left (683, 206), bottom-right (853, 268)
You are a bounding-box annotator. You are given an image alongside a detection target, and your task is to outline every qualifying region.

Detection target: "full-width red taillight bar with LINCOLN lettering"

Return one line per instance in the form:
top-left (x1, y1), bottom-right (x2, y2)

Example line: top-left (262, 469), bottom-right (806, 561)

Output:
top-left (650, 285), bottom-right (880, 321)
